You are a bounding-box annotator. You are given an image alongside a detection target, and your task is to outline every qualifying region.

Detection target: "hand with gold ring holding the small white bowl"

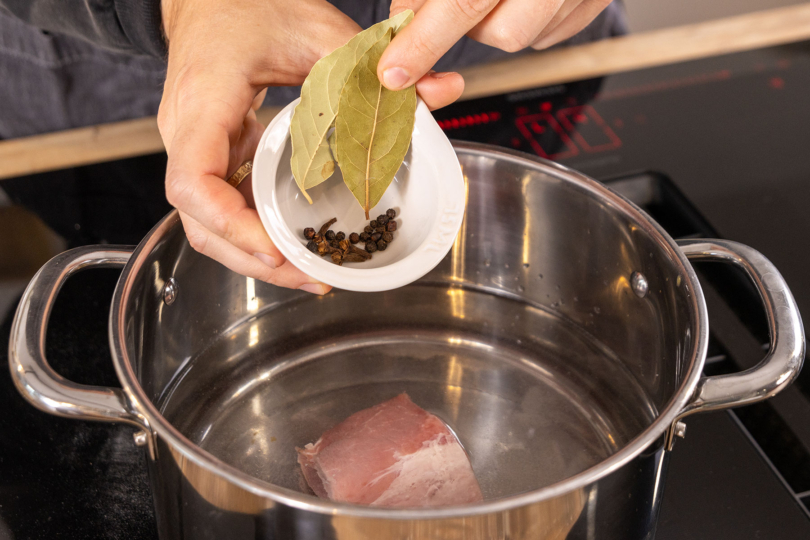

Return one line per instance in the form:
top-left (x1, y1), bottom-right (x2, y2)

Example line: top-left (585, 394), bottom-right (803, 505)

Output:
top-left (158, 0), bottom-right (464, 294)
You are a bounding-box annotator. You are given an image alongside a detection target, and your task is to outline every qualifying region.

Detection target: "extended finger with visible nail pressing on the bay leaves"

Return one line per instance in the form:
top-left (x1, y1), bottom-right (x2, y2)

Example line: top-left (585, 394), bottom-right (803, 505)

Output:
top-left (377, 0), bottom-right (498, 90)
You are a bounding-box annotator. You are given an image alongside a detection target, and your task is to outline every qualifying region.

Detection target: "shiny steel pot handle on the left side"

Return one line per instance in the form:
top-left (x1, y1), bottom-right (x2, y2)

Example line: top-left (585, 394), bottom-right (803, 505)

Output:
top-left (8, 246), bottom-right (154, 454)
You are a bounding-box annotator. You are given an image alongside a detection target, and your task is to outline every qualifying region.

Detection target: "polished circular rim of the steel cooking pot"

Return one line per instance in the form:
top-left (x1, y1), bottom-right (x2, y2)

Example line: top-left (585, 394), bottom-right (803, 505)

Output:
top-left (109, 141), bottom-right (709, 520)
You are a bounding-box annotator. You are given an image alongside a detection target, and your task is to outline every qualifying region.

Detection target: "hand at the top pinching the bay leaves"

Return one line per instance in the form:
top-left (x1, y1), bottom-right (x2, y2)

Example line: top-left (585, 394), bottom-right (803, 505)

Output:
top-left (377, 0), bottom-right (611, 90)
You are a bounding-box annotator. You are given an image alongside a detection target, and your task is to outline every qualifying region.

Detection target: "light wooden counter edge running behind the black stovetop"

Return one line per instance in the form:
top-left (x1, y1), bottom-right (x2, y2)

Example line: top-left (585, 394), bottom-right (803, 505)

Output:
top-left (0, 3), bottom-right (810, 179)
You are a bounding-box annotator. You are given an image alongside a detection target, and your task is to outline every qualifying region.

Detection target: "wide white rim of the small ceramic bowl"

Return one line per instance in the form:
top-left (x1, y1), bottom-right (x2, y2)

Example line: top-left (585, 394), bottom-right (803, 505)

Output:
top-left (252, 98), bottom-right (467, 292)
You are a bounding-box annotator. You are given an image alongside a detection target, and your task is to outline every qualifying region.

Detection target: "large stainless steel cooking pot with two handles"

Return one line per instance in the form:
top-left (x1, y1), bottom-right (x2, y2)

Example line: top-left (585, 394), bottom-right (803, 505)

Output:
top-left (10, 144), bottom-right (804, 540)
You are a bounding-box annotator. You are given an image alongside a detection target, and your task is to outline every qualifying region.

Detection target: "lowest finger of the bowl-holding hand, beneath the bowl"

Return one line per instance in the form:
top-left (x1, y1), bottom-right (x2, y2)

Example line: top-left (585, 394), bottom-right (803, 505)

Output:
top-left (180, 212), bottom-right (331, 294)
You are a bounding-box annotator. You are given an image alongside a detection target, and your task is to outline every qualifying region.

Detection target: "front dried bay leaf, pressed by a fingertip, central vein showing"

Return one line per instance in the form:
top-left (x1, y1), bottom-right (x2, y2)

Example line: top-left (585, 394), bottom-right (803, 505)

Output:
top-left (335, 31), bottom-right (416, 219)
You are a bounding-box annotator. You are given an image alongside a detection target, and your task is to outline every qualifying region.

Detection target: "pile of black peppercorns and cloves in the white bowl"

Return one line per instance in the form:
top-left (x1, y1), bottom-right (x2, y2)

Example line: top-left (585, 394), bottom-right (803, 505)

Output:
top-left (304, 208), bottom-right (397, 266)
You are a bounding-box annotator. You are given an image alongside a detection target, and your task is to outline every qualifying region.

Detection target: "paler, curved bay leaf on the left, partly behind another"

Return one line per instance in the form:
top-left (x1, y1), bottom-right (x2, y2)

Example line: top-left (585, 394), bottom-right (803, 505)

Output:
top-left (290, 10), bottom-right (413, 204)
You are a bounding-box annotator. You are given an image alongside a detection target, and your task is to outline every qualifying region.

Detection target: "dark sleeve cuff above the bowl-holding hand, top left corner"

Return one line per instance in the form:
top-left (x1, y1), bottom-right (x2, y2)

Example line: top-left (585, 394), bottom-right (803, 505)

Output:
top-left (0, 0), bottom-right (167, 59)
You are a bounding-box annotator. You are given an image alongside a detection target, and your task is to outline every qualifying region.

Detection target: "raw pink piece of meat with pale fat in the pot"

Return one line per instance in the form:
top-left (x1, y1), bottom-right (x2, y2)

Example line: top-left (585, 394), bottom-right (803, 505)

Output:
top-left (296, 394), bottom-right (483, 507)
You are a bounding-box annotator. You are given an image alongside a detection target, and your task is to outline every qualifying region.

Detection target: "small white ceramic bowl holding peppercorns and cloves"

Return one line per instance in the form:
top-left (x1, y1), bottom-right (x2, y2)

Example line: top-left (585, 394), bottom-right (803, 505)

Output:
top-left (253, 100), bottom-right (466, 291)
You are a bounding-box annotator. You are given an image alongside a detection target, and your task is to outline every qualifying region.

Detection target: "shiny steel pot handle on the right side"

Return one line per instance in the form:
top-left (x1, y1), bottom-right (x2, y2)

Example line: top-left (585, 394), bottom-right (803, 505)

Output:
top-left (676, 239), bottom-right (805, 431)
